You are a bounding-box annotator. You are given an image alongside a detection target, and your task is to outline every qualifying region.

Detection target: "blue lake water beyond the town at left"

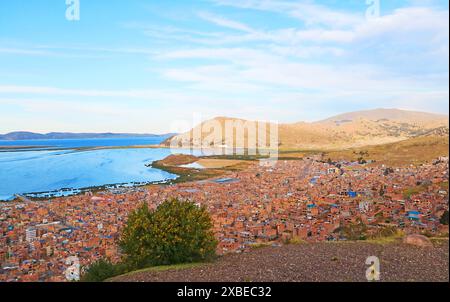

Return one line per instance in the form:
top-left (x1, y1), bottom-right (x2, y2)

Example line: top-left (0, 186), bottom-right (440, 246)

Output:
top-left (0, 137), bottom-right (197, 200)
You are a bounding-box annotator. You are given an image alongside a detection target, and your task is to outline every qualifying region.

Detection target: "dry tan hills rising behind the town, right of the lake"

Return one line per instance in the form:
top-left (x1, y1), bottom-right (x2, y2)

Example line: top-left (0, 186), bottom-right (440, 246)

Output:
top-left (163, 109), bottom-right (449, 150)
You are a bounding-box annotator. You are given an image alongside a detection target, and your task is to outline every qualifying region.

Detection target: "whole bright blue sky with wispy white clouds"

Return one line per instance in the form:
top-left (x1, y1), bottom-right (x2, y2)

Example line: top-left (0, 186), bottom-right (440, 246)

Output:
top-left (0, 0), bottom-right (449, 133)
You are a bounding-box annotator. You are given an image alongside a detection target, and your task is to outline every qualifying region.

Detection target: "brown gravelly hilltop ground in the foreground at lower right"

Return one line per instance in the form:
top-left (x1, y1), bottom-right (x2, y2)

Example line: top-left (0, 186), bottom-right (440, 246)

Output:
top-left (114, 240), bottom-right (449, 282)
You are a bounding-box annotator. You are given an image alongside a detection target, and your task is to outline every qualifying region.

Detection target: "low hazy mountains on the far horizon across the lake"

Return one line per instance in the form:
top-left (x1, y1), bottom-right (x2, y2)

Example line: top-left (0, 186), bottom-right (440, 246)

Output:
top-left (0, 131), bottom-right (174, 141)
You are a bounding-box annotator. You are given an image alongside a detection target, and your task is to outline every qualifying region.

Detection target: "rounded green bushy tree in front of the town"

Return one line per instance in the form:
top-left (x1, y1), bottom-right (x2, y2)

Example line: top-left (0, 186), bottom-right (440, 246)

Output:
top-left (119, 199), bottom-right (217, 268)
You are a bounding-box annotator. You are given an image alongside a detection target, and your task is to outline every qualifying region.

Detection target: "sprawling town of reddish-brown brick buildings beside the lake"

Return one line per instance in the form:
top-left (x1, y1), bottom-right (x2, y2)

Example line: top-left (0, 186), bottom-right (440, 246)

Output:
top-left (0, 156), bottom-right (449, 282)
